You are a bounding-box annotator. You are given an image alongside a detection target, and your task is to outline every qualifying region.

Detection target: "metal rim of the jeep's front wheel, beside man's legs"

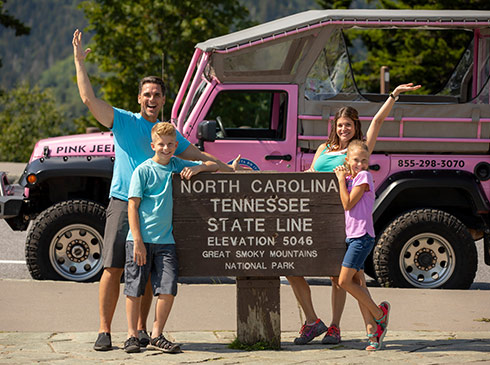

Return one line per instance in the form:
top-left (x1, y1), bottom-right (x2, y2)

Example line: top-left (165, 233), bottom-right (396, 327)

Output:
top-left (49, 224), bottom-right (102, 281)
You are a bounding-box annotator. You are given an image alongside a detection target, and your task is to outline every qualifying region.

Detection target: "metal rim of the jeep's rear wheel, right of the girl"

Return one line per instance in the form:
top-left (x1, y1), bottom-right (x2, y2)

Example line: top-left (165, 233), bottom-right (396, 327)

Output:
top-left (400, 233), bottom-right (456, 288)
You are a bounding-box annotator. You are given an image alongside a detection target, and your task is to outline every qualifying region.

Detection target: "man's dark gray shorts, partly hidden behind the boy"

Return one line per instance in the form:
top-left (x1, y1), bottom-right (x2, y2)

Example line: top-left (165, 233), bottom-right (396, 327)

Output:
top-left (102, 198), bottom-right (129, 269)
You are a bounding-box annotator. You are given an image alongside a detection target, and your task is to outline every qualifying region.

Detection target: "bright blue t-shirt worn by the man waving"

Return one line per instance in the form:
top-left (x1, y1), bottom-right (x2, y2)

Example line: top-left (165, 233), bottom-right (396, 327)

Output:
top-left (109, 108), bottom-right (190, 201)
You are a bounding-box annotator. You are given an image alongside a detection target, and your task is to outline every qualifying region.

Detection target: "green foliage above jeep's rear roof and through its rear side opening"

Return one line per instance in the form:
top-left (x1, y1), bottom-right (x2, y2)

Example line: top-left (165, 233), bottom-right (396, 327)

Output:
top-left (317, 0), bottom-right (490, 94)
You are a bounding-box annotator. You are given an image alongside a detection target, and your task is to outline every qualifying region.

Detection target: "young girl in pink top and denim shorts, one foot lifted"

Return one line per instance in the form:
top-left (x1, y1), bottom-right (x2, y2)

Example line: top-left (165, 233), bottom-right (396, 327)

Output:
top-left (334, 140), bottom-right (390, 351)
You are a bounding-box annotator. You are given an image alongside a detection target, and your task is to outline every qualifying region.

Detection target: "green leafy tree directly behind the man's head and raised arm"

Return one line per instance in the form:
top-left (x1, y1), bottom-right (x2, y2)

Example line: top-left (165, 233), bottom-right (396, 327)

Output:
top-left (81, 0), bottom-right (248, 117)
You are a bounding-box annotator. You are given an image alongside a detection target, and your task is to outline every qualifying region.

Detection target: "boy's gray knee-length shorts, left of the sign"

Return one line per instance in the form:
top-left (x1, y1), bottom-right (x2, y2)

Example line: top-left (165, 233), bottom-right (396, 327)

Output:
top-left (124, 241), bottom-right (179, 297)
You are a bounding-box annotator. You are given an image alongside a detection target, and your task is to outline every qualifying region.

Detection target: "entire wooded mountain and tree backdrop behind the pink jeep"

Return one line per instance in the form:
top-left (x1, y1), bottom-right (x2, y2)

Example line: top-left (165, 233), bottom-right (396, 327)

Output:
top-left (0, 0), bottom-right (490, 162)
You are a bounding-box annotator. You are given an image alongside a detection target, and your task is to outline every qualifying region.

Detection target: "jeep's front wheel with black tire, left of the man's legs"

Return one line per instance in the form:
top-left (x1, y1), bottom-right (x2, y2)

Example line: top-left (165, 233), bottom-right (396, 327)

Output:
top-left (26, 200), bottom-right (105, 282)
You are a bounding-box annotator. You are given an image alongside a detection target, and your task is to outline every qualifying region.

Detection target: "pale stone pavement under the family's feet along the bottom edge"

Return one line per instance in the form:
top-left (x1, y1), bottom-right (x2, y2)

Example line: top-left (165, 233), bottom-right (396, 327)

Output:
top-left (0, 331), bottom-right (490, 365)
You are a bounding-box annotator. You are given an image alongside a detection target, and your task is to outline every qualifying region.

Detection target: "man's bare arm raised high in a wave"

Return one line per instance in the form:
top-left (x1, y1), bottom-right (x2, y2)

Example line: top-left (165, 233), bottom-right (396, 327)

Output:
top-left (72, 29), bottom-right (114, 128)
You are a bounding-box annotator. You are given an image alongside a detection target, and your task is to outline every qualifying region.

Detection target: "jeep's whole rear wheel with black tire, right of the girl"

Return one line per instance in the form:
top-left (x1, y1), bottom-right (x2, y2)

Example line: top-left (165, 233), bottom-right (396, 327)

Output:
top-left (373, 209), bottom-right (477, 289)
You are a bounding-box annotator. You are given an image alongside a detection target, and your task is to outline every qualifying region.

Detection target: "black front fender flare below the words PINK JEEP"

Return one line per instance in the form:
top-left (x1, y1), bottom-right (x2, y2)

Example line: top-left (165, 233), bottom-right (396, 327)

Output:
top-left (20, 156), bottom-right (114, 188)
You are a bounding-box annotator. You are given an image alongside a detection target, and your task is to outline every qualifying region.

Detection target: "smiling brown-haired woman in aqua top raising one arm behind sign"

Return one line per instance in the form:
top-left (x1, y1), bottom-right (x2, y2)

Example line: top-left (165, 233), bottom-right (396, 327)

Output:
top-left (287, 83), bottom-right (421, 345)
